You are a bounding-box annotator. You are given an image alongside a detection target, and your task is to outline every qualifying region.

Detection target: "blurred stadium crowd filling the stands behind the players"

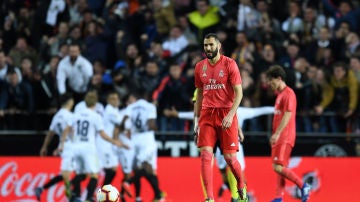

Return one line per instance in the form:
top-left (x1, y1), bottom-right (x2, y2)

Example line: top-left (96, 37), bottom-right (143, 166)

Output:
top-left (0, 0), bottom-right (360, 133)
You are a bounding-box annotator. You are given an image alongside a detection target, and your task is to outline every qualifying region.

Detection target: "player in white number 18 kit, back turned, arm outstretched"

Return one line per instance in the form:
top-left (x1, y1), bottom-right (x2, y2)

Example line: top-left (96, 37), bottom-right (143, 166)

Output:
top-left (59, 92), bottom-right (127, 201)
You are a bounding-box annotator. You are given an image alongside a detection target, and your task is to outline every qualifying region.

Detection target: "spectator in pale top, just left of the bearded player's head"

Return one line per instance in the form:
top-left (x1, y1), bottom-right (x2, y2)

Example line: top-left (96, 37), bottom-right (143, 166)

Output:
top-left (162, 25), bottom-right (189, 56)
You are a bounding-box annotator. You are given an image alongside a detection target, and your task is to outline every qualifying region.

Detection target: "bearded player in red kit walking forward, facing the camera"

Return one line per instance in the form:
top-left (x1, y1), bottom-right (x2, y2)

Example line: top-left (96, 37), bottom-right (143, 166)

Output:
top-left (194, 33), bottom-right (247, 201)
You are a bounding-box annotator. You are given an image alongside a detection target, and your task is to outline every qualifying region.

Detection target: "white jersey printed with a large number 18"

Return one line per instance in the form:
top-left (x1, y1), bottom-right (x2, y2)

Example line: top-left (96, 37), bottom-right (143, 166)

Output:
top-left (72, 108), bottom-right (104, 144)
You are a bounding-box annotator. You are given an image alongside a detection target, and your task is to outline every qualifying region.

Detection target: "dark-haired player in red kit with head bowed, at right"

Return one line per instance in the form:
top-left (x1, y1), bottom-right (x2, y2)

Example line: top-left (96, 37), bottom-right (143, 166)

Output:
top-left (266, 65), bottom-right (310, 202)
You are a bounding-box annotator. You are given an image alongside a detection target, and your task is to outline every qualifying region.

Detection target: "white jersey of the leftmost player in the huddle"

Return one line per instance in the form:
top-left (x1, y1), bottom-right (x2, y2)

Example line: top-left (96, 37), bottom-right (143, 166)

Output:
top-left (49, 108), bottom-right (74, 141)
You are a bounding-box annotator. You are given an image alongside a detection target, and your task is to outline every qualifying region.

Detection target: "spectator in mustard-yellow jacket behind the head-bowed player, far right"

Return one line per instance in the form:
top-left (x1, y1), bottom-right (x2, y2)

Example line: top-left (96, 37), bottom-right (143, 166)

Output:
top-left (315, 62), bottom-right (359, 133)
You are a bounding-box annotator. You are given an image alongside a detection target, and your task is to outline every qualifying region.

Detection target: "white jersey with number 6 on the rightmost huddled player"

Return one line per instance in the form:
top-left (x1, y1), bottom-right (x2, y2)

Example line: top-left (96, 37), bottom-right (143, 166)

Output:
top-left (125, 99), bottom-right (157, 134)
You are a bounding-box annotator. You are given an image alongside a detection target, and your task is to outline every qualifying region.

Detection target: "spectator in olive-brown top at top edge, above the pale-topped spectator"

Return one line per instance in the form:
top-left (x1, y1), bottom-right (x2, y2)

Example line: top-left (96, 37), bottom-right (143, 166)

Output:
top-left (152, 0), bottom-right (176, 38)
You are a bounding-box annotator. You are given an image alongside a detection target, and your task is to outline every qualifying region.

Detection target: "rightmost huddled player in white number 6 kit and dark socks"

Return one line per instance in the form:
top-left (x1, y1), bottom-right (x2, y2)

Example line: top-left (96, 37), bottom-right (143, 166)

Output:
top-left (123, 91), bottom-right (165, 202)
